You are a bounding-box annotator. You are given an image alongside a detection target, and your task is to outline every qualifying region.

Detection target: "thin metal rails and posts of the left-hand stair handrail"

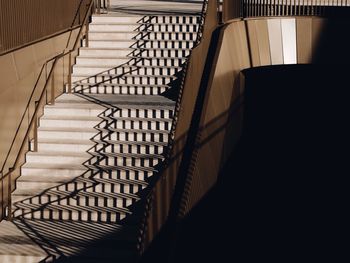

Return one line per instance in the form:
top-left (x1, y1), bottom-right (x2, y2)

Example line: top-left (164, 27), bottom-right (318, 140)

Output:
top-left (0, 0), bottom-right (95, 220)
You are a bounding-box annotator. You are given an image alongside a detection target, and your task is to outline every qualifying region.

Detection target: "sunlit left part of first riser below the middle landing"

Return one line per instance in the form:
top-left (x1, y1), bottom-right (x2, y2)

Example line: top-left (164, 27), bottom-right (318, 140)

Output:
top-left (44, 106), bottom-right (104, 117)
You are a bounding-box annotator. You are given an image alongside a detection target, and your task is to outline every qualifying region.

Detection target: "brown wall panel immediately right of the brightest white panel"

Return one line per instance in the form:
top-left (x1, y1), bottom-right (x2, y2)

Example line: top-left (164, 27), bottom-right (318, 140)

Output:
top-left (296, 18), bottom-right (312, 64)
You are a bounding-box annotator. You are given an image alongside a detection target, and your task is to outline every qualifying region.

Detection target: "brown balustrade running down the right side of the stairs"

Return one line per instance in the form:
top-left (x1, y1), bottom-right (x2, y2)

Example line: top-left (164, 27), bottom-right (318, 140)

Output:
top-left (138, 0), bottom-right (220, 254)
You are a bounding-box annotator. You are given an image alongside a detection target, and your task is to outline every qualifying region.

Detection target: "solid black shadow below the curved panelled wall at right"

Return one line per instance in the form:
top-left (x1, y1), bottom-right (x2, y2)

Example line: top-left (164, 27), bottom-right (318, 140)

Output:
top-left (143, 65), bottom-right (350, 262)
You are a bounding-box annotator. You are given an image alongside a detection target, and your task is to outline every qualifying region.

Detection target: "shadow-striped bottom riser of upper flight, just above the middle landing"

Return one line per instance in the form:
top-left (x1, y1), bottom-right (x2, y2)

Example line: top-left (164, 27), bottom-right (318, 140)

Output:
top-left (74, 86), bottom-right (168, 95)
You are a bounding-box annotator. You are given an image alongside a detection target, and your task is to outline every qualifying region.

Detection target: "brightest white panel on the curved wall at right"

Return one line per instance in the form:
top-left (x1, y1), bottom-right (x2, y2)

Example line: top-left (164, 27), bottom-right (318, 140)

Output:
top-left (281, 18), bottom-right (297, 64)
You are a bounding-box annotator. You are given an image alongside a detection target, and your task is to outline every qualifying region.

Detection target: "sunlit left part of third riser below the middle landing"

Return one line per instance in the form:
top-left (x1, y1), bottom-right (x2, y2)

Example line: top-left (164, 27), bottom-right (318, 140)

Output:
top-left (38, 129), bottom-right (99, 140)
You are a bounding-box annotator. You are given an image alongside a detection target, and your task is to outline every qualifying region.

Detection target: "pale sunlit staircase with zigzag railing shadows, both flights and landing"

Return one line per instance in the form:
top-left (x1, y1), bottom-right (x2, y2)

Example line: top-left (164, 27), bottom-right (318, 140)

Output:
top-left (0, 8), bottom-right (199, 262)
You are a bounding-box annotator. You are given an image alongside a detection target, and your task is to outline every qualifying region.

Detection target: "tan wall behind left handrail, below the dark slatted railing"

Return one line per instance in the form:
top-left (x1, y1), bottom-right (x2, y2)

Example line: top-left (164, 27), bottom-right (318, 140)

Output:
top-left (0, 31), bottom-right (77, 172)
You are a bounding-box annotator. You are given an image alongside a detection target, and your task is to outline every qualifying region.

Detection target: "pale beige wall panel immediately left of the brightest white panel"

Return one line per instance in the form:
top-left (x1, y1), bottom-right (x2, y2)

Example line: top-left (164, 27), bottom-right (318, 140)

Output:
top-left (267, 19), bottom-right (283, 65)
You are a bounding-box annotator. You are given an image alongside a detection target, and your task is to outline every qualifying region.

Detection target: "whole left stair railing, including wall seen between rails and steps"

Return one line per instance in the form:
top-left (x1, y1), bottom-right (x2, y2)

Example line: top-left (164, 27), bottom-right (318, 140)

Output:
top-left (0, 0), bottom-right (99, 223)
